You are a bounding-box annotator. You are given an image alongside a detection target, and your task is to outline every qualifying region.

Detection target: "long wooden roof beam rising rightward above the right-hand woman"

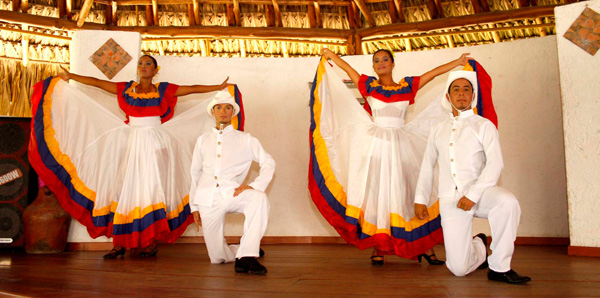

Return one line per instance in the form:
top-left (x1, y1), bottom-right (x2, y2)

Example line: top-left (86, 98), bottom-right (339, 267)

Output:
top-left (358, 5), bottom-right (560, 40)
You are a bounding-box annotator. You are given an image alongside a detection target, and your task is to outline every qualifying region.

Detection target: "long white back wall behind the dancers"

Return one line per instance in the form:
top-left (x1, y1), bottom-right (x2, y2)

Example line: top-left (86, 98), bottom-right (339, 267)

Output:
top-left (69, 32), bottom-right (568, 242)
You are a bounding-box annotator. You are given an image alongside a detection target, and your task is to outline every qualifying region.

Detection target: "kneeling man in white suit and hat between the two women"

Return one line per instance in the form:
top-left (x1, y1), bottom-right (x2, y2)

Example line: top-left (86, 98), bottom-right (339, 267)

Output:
top-left (190, 90), bottom-right (275, 274)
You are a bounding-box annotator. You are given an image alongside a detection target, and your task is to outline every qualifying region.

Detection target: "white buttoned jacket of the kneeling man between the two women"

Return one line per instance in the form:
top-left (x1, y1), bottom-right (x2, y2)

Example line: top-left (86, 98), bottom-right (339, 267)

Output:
top-left (190, 125), bottom-right (275, 212)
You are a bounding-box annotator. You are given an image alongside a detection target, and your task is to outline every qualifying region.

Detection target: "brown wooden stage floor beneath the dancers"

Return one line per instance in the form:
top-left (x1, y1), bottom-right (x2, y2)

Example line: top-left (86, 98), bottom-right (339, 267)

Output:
top-left (0, 244), bottom-right (600, 298)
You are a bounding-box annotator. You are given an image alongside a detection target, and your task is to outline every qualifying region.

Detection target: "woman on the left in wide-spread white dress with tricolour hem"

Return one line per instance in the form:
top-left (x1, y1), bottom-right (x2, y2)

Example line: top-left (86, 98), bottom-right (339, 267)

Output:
top-left (30, 55), bottom-right (230, 259)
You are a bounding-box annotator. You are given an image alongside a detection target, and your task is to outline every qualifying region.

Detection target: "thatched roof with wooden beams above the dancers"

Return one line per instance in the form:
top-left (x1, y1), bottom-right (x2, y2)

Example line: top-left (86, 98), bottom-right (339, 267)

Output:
top-left (0, 0), bottom-right (575, 63)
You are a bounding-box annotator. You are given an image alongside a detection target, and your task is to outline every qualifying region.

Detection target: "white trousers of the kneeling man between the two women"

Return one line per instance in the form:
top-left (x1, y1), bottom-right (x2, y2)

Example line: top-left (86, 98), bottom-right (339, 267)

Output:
top-left (199, 189), bottom-right (269, 264)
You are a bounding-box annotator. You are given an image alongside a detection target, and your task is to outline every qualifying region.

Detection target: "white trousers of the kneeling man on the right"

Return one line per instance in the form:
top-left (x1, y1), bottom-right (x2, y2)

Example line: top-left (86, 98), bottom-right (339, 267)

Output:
top-left (440, 187), bottom-right (521, 276)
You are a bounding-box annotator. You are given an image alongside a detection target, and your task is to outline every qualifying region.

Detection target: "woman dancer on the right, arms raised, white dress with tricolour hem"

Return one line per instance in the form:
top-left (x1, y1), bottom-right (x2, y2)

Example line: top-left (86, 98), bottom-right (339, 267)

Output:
top-left (311, 49), bottom-right (470, 265)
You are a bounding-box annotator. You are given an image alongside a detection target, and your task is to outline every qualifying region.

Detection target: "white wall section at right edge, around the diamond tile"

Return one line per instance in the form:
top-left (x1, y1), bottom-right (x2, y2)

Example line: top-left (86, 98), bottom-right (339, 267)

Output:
top-left (555, 0), bottom-right (600, 247)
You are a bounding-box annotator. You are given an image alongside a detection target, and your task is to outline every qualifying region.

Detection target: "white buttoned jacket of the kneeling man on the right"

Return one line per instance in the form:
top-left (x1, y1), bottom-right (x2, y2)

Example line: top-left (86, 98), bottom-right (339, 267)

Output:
top-left (415, 110), bottom-right (504, 205)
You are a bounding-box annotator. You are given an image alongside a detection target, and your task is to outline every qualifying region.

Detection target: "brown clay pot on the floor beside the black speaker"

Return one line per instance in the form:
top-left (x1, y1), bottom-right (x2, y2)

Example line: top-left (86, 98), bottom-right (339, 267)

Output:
top-left (23, 186), bottom-right (71, 254)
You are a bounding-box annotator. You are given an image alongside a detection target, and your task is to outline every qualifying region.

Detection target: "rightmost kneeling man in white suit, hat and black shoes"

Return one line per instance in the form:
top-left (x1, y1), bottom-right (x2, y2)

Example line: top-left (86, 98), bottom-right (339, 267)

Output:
top-left (415, 71), bottom-right (531, 284)
